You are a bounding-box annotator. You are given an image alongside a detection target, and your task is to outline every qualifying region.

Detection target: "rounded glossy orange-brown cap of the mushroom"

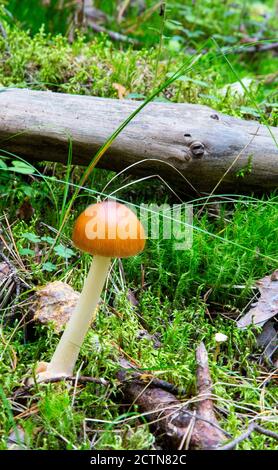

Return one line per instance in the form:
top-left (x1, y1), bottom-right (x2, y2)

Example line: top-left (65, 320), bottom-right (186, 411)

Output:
top-left (72, 201), bottom-right (146, 258)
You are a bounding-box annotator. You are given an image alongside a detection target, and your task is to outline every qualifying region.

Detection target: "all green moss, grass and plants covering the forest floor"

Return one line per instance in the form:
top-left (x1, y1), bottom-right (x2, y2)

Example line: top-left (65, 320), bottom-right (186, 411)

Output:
top-left (0, 0), bottom-right (278, 449)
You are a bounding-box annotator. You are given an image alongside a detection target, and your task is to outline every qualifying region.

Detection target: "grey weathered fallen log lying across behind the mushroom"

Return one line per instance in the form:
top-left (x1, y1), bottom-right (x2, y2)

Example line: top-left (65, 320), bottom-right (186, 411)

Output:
top-left (0, 89), bottom-right (278, 192)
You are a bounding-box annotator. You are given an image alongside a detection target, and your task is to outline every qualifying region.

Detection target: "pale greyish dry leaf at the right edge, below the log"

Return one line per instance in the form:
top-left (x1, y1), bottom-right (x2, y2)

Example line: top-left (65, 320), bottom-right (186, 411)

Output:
top-left (237, 270), bottom-right (278, 328)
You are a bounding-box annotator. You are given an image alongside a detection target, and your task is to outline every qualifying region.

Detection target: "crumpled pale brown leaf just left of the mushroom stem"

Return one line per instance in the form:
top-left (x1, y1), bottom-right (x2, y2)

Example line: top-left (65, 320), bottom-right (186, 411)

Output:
top-left (32, 281), bottom-right (79, 333)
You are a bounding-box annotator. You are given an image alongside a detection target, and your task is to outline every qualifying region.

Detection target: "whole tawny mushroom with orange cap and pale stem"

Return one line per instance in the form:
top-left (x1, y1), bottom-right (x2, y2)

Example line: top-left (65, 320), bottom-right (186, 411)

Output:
top-left (38, 201), bottom-right (146, 379)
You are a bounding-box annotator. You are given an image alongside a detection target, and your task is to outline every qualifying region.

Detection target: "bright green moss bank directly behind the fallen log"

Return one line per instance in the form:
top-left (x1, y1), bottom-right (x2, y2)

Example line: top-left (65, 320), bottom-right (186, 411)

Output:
top-left (0, 18), bottom-right (278, 124)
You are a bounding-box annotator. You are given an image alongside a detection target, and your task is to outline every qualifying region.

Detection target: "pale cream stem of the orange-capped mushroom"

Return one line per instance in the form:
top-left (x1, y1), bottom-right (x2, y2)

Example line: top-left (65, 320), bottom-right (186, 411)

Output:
top-left (47, 256), bottom-right (111, 377)
